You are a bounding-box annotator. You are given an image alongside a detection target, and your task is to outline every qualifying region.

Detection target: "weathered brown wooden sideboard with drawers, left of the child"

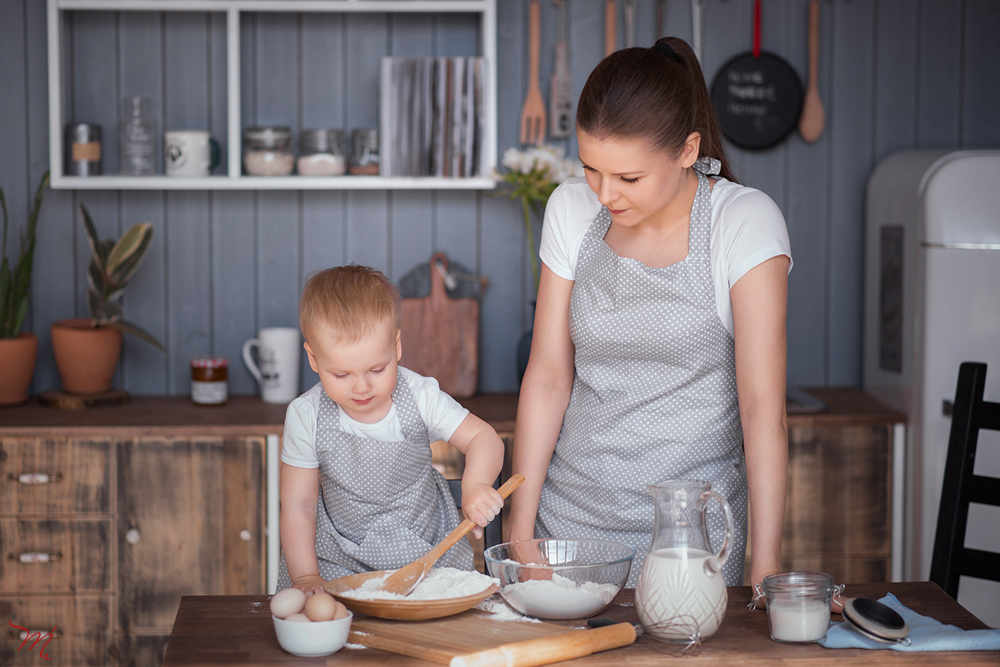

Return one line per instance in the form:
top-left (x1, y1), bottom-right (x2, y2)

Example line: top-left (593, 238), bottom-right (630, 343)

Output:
top-left (0, 398), bottom-right (284, 666)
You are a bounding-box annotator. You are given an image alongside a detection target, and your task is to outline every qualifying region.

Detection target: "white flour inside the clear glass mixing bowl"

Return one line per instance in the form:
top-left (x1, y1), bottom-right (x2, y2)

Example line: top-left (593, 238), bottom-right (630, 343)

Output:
top-left (501, 573), bottom-right (618, 620)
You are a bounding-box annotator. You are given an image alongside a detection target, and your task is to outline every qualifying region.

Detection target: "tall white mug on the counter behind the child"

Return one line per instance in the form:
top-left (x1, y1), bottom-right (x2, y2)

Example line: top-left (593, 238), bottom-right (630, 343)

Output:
top-left (243, 327), bottom-right (302, 403)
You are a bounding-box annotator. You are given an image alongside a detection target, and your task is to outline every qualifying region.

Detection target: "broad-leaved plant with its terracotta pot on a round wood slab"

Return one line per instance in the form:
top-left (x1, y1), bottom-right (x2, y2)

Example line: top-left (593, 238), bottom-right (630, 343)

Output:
top-left (52, 203), bottom-right (164, 394)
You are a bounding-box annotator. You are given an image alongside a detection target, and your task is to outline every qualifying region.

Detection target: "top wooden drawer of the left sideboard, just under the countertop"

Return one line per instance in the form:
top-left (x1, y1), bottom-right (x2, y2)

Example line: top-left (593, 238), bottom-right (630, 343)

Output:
top-left (0, 438), bottom-right (111, 515)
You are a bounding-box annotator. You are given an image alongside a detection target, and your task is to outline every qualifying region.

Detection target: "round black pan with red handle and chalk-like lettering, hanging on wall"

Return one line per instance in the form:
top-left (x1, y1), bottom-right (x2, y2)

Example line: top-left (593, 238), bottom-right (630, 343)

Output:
top-left (712, 0), bottom-right (802, 150)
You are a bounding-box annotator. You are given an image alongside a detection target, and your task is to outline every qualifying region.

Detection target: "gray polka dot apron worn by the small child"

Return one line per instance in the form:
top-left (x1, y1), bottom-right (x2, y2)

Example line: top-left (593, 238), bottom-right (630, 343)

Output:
top-left (278, 373), bottom-right (473, 590)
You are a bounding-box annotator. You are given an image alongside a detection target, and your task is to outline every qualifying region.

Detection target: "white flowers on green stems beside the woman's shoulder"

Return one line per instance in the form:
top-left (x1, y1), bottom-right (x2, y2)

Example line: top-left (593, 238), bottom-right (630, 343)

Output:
top-left (495, 144), bottom-right (583, 294)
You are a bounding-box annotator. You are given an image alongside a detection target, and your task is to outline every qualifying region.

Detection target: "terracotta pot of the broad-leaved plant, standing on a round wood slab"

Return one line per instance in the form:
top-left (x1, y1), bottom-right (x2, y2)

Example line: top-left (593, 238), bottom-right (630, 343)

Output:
top-left (52, 317), bottom-right (122, 394)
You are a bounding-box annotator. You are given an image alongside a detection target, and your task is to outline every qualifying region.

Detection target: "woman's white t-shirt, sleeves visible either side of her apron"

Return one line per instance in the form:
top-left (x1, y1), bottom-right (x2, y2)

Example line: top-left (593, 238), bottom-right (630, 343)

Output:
top-left (539, 176), bottom-right (792, 335)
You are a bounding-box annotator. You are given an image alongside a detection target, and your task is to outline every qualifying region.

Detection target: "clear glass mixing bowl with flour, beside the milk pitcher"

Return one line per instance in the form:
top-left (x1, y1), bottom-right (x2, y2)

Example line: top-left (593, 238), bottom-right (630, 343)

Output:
top-left (483, 539), bottom-right (635, 620)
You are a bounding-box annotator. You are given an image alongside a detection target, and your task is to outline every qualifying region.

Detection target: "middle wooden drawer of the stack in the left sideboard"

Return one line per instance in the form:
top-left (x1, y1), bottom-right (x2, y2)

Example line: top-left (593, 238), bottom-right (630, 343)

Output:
top-left (0, 519), bottom-right (111, 593)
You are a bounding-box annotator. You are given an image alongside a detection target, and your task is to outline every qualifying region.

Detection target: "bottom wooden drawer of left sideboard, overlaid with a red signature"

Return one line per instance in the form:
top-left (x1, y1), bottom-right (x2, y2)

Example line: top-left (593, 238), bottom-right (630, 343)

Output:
top-left (0, 596), bottom-right (113, 667)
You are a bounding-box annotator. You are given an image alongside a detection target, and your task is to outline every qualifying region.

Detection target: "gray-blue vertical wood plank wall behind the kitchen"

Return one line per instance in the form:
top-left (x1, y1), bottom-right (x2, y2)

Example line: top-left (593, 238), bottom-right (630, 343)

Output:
top-left (0, 0), bottom-right (1000, 394)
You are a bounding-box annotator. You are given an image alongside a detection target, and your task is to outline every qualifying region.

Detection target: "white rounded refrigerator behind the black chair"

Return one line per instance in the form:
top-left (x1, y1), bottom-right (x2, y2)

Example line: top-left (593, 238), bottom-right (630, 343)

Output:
top-left (863, 150), bottom-right (1000, 627)
